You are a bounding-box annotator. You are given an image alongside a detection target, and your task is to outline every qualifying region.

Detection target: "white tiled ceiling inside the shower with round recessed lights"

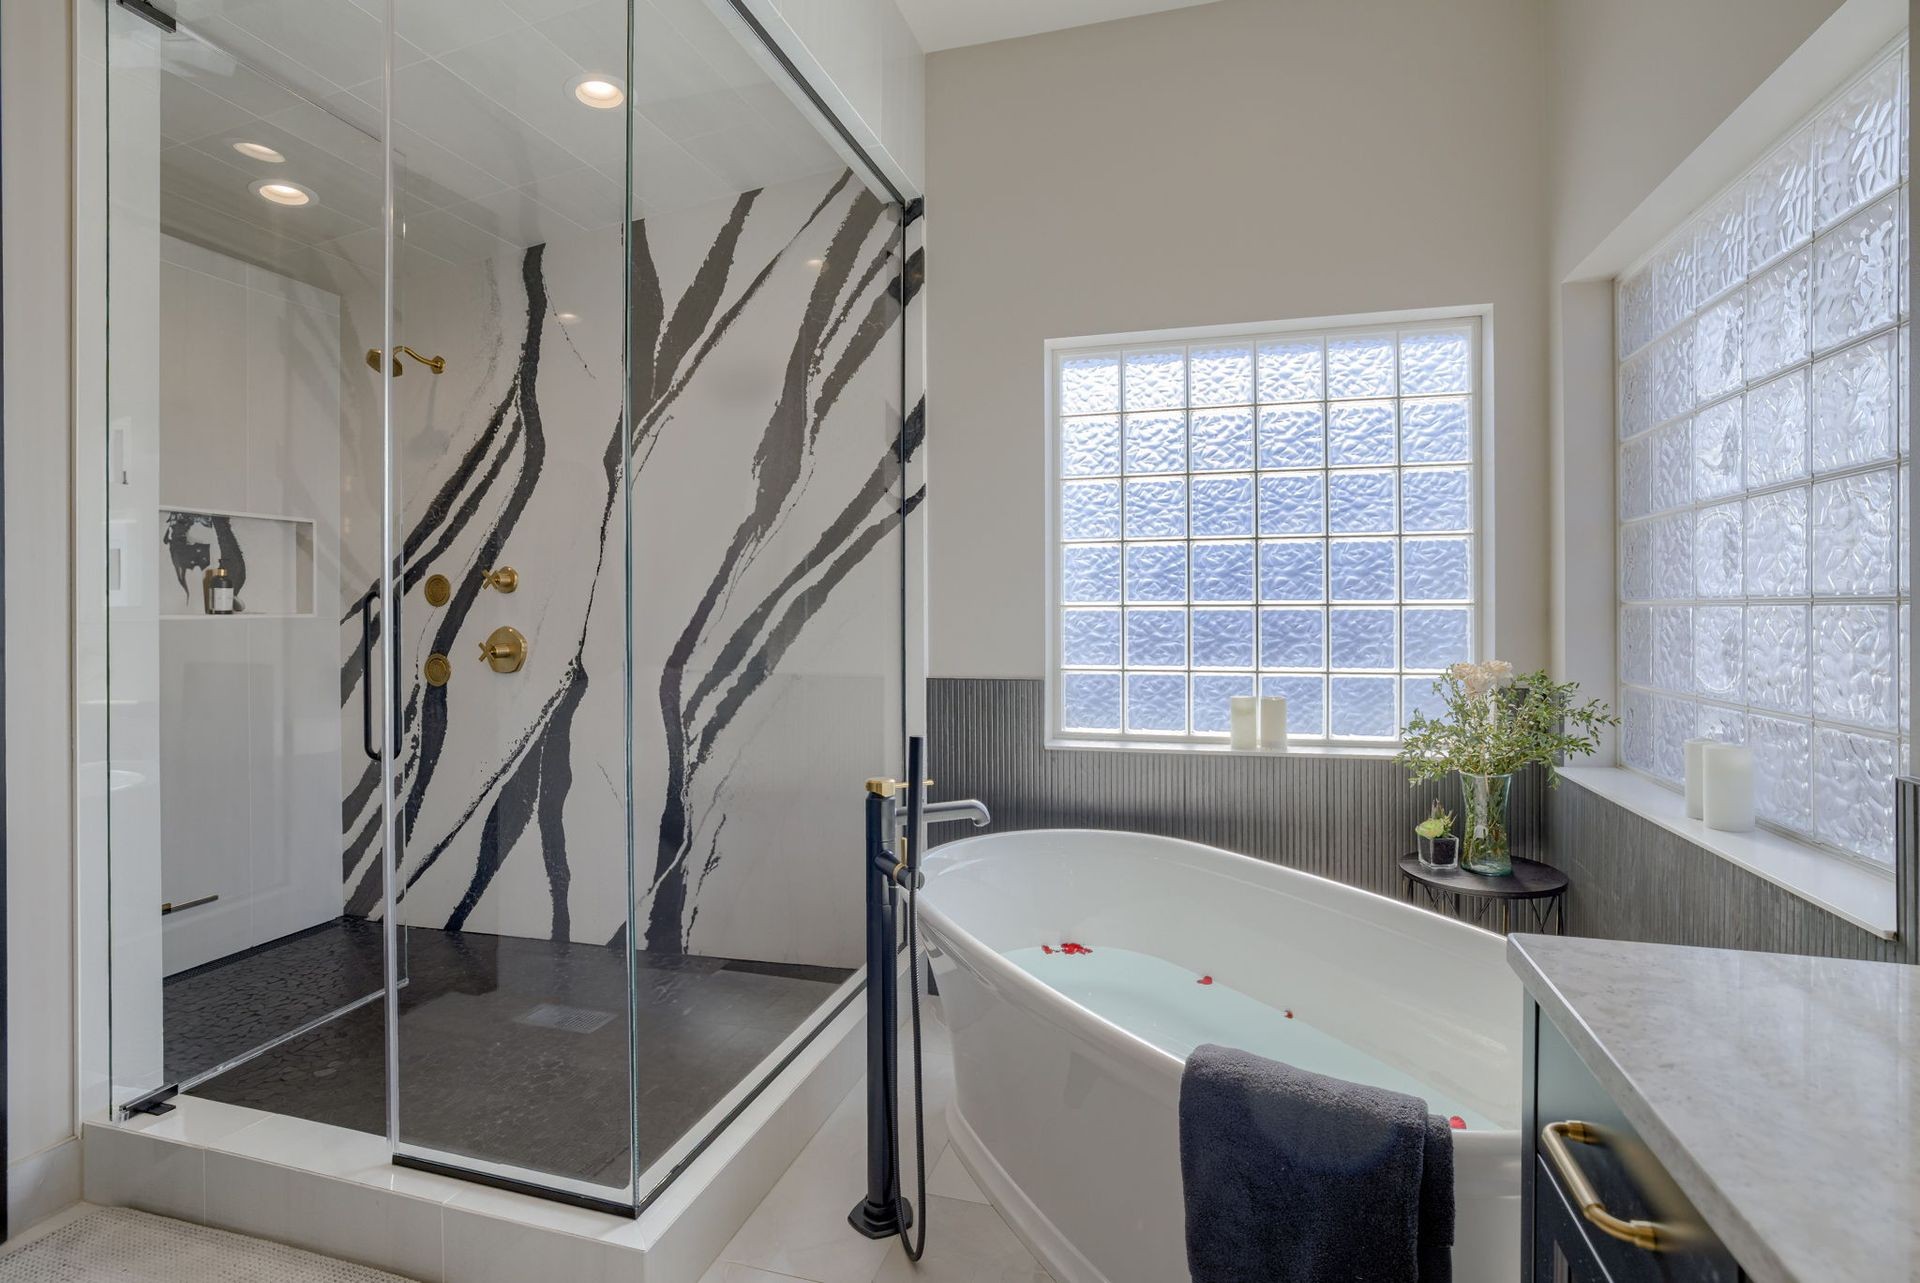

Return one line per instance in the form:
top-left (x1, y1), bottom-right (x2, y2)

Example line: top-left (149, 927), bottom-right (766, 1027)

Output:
top-left (149, 0), bottom-right (841, 278)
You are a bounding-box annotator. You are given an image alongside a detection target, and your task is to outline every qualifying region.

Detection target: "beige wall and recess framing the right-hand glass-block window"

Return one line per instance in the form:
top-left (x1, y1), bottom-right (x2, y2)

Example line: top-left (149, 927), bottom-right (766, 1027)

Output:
top-left (1546, 0), bottom-right (1908, 745)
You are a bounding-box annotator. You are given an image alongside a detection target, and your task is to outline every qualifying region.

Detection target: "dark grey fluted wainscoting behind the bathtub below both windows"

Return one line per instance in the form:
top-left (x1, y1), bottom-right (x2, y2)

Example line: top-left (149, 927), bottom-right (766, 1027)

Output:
top-left (927, 678), bottom-right (1920, 960)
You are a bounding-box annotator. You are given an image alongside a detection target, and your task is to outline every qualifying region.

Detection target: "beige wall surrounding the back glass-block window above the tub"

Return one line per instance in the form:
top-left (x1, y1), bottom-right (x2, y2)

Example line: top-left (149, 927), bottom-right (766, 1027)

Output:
top-left (927, 0), bottom-right (1548, 676)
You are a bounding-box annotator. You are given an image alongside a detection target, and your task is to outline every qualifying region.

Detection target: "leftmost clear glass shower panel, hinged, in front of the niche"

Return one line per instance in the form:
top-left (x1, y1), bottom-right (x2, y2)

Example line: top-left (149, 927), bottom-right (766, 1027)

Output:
top-left (102, 0), bottom-right (397, 1112)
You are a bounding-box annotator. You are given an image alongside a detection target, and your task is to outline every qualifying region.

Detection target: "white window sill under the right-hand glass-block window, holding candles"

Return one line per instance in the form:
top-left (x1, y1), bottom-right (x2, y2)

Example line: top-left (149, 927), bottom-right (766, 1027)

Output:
top-left (1561, 766), bottom-right (1899, 939)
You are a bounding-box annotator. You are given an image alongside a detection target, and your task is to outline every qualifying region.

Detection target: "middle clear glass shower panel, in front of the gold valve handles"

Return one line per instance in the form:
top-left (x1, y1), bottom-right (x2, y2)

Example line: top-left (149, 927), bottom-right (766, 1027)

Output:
top-left (386, 0), bottom-right (634, 1208)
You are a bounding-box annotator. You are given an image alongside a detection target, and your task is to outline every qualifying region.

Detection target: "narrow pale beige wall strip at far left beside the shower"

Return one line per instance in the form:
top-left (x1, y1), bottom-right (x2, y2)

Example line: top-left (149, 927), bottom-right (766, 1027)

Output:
top-left (0, 0), bottom-right (81, 1231)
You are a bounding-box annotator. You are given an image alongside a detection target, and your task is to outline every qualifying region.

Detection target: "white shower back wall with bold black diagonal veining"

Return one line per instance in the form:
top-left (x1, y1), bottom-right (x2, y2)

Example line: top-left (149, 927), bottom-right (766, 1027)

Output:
top-left (340, 175), bottom-right (920, 966)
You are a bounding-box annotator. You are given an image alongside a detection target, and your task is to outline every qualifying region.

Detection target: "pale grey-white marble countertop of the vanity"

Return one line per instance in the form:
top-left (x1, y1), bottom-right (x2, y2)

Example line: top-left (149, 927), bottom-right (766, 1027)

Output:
top-left (1507, 935), bottom-right (1920, 1283)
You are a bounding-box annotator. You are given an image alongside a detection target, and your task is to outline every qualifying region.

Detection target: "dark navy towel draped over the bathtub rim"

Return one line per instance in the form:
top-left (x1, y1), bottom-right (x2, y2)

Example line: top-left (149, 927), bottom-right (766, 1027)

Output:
top-left (1181, 1043), bottom-right (1453, 1283)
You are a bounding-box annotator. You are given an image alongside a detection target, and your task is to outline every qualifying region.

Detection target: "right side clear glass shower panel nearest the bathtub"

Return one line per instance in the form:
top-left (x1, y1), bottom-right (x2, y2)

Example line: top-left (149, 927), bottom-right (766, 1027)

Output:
top-left (614, 4), bottom-right (924, 1206)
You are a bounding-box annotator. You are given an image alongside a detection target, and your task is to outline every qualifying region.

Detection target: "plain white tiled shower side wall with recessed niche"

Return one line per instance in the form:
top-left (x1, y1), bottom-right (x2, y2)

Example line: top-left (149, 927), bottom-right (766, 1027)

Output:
top-left (150, 236), bottom-right (343, 974)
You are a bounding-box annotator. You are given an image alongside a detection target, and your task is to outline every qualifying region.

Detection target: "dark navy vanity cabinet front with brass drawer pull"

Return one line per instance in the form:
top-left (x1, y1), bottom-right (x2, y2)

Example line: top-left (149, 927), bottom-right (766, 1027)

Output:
top-left (1521, 1001), bottom-right (1745, 1283)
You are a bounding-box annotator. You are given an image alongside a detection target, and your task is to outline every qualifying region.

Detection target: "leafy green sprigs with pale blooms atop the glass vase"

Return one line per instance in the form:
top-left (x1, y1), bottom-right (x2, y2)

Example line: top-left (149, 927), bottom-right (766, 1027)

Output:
top-left (1400, 659), bottom-right (1620, 784)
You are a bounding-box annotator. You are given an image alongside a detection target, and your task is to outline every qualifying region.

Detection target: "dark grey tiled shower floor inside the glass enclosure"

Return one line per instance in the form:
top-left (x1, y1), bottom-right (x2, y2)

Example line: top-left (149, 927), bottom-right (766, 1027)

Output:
top-left (183, 926), bottom-right (851, 1185)
